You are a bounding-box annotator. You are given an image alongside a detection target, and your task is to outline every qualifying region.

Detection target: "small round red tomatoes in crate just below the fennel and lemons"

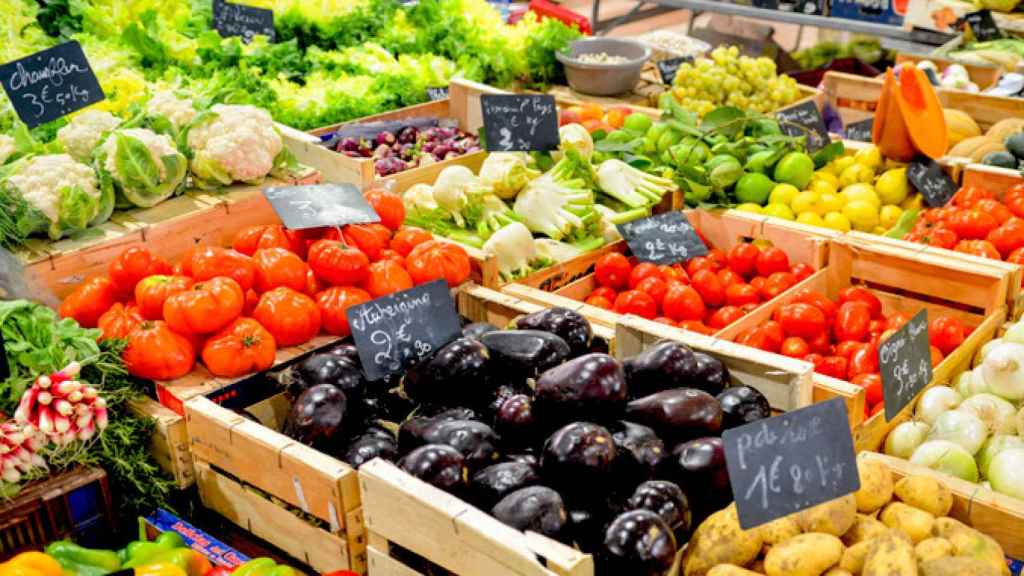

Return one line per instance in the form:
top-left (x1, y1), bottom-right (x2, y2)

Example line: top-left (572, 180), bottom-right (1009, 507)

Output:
top-left (585, 242), bottom-right (814, 334)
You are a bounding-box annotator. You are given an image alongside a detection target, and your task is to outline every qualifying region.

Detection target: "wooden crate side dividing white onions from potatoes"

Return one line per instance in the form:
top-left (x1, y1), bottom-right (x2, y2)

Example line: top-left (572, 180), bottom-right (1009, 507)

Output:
top-left (857, 452), bottom-right (1024, 559)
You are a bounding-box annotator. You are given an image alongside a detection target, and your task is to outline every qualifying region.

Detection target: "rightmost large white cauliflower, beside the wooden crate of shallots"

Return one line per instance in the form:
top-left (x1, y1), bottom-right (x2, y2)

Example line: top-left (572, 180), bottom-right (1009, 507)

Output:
top-left (186, 105), bottom-right (287, 188)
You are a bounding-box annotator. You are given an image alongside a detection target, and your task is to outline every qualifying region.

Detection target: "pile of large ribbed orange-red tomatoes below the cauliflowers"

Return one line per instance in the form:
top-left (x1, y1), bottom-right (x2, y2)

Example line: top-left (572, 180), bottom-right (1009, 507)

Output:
top-left (60, 191), bottom-right (470, 380)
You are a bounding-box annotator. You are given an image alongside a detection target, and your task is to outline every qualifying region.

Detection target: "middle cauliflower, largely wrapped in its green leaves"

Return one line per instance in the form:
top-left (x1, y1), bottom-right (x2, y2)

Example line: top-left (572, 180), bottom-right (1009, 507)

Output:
top-left (96, 128), bottom-right (188, 208)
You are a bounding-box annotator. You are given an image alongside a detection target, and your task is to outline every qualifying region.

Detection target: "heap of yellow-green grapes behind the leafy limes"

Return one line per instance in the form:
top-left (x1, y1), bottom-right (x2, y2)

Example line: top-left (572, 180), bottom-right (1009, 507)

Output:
top-left (673, 46), bottom-right (800, 116)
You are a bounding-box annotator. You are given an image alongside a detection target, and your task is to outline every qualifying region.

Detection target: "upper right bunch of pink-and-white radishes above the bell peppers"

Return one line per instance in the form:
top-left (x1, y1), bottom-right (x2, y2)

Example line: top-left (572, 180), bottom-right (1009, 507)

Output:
top-left (14, 362), bottom-right (108, 445)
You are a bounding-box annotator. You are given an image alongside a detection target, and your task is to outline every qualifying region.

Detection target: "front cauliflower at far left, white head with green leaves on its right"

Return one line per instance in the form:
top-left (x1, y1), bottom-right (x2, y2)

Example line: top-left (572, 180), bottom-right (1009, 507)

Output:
top-left (0, 154), bottom-right (114, 240)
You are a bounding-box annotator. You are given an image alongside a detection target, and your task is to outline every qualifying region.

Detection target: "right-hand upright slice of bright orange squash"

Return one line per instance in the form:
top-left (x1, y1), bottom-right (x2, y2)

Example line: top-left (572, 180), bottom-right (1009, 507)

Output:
top-left (898, 67), bottom-right (949, 158)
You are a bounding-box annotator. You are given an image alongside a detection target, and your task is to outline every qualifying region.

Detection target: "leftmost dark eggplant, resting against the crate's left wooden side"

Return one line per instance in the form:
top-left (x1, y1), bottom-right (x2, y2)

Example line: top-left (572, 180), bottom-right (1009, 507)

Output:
top-left (284, 384), bottom-right (348, 449)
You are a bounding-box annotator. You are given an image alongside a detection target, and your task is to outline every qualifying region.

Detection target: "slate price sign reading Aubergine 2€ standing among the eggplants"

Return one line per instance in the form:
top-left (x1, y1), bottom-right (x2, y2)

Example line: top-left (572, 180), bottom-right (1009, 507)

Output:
top-left (345, 280), bottom-right (462, 380)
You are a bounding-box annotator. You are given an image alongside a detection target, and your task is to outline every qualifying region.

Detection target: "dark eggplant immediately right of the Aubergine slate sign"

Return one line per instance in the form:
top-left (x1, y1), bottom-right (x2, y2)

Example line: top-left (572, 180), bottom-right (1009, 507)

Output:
top-left (402, 337), bottom-right (490, 406)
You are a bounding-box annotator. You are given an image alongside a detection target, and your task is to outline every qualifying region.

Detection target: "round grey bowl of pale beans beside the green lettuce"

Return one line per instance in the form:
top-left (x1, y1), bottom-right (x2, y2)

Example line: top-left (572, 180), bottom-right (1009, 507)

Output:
top-left (555, 37), bottom-right (650, 96)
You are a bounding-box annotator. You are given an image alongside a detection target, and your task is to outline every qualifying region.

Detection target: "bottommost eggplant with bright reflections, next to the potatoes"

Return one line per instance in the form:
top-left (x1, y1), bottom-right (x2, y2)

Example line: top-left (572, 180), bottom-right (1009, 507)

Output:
top-left (594, 509), bottom-right (677, 576)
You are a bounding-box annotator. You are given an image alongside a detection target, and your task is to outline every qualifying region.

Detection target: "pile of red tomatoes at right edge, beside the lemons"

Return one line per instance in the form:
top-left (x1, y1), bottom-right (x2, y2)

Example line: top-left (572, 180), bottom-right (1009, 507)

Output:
top-left (904, 184), bottom-right (1024, 272)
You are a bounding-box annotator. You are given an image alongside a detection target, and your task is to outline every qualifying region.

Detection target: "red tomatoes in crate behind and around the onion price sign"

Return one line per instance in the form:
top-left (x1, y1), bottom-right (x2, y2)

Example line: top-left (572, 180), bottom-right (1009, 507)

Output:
top-left (736, 286), bottom-right (971, 415)
